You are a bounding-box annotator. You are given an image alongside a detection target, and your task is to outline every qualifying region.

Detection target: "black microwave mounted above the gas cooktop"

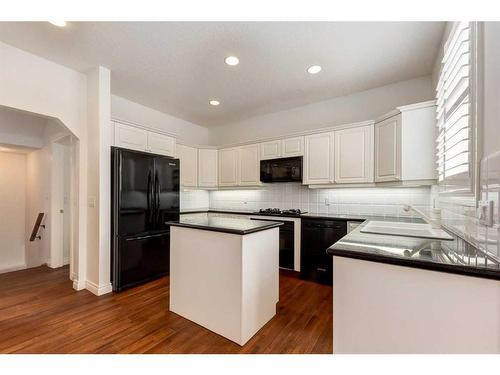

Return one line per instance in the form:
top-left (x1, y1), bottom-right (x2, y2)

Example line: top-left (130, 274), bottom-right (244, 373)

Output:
top-left (260, 156), bottom-right (302, 182)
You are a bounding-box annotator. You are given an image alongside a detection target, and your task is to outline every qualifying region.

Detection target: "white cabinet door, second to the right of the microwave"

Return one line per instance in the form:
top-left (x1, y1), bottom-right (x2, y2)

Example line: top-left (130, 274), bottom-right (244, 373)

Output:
top-left (334, 125), bottom-right (373, 184)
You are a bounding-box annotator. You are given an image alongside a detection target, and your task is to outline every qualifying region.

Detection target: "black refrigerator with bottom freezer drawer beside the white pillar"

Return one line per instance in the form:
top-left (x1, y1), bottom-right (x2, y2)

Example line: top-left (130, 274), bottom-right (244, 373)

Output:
top-left (111, 147), bottom-right (179, 292)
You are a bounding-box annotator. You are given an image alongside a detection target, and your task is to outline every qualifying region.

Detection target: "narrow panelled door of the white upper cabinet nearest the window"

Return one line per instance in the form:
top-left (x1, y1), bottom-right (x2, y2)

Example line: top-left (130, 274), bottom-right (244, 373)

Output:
top-left (375, 115), bottom-right (402, 182)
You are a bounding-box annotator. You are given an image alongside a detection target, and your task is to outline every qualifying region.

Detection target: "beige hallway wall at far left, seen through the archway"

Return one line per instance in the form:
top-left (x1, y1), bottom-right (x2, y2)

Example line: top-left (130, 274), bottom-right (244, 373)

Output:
top-left (0, 152), bottom-right (29, 273)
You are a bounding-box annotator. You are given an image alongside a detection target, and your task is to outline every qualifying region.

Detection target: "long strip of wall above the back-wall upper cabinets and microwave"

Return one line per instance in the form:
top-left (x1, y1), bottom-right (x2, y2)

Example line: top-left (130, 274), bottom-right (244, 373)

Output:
top-left (209, 76), bottom-right (434, 145)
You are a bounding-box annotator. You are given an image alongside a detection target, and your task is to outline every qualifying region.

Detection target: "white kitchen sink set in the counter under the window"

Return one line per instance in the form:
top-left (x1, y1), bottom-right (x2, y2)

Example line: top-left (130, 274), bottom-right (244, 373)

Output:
top-left (360, 221), bottom-right (453, 241)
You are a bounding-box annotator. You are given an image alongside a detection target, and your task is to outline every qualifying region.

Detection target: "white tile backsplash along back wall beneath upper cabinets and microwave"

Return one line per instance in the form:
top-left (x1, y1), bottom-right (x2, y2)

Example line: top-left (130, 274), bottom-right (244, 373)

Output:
top-left (209, 183), bottom-right (430, 216)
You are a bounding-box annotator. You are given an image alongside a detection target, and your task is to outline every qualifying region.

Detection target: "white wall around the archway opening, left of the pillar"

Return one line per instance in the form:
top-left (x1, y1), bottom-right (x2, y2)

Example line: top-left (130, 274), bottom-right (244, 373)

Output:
top-left (0, 43), bottom-right (87, 289)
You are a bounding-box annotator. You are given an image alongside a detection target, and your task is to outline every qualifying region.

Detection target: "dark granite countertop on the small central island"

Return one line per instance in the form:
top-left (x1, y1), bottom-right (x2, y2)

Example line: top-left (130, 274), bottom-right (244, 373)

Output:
top-left (167, 217), bottom-right (283, 235)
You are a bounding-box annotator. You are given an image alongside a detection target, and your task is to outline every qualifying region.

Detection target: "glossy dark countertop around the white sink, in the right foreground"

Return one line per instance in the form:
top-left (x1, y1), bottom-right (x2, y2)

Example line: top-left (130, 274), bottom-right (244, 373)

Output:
top-left (327, 218), bottom-right (500, 280)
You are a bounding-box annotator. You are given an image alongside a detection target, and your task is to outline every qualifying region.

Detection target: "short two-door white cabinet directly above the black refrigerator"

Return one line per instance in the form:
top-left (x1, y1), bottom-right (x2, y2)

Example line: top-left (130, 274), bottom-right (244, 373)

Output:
top-left (114, 122), bottom-right (175, 156)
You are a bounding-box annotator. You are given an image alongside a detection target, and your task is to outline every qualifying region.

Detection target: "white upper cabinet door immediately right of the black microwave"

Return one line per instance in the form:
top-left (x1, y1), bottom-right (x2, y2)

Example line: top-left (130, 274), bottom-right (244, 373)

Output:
top-left (304, 132), bottom-right (333, 185)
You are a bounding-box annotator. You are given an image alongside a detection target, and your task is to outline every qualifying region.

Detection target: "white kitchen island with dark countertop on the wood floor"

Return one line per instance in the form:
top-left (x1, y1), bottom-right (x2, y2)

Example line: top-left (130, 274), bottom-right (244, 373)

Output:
top-left (167, 217), bottom-right (282, 345)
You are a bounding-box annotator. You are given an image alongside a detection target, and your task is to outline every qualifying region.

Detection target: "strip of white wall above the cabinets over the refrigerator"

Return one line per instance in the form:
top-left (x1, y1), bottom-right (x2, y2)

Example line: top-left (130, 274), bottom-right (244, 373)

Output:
top-left (111, 95), bottom-right (208, 145)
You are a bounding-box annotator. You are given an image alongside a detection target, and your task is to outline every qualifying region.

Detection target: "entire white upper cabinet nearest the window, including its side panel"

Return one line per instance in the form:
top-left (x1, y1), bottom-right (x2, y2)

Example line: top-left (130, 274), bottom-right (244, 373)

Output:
top-left (375, 101), bottom-right (436, 182)
